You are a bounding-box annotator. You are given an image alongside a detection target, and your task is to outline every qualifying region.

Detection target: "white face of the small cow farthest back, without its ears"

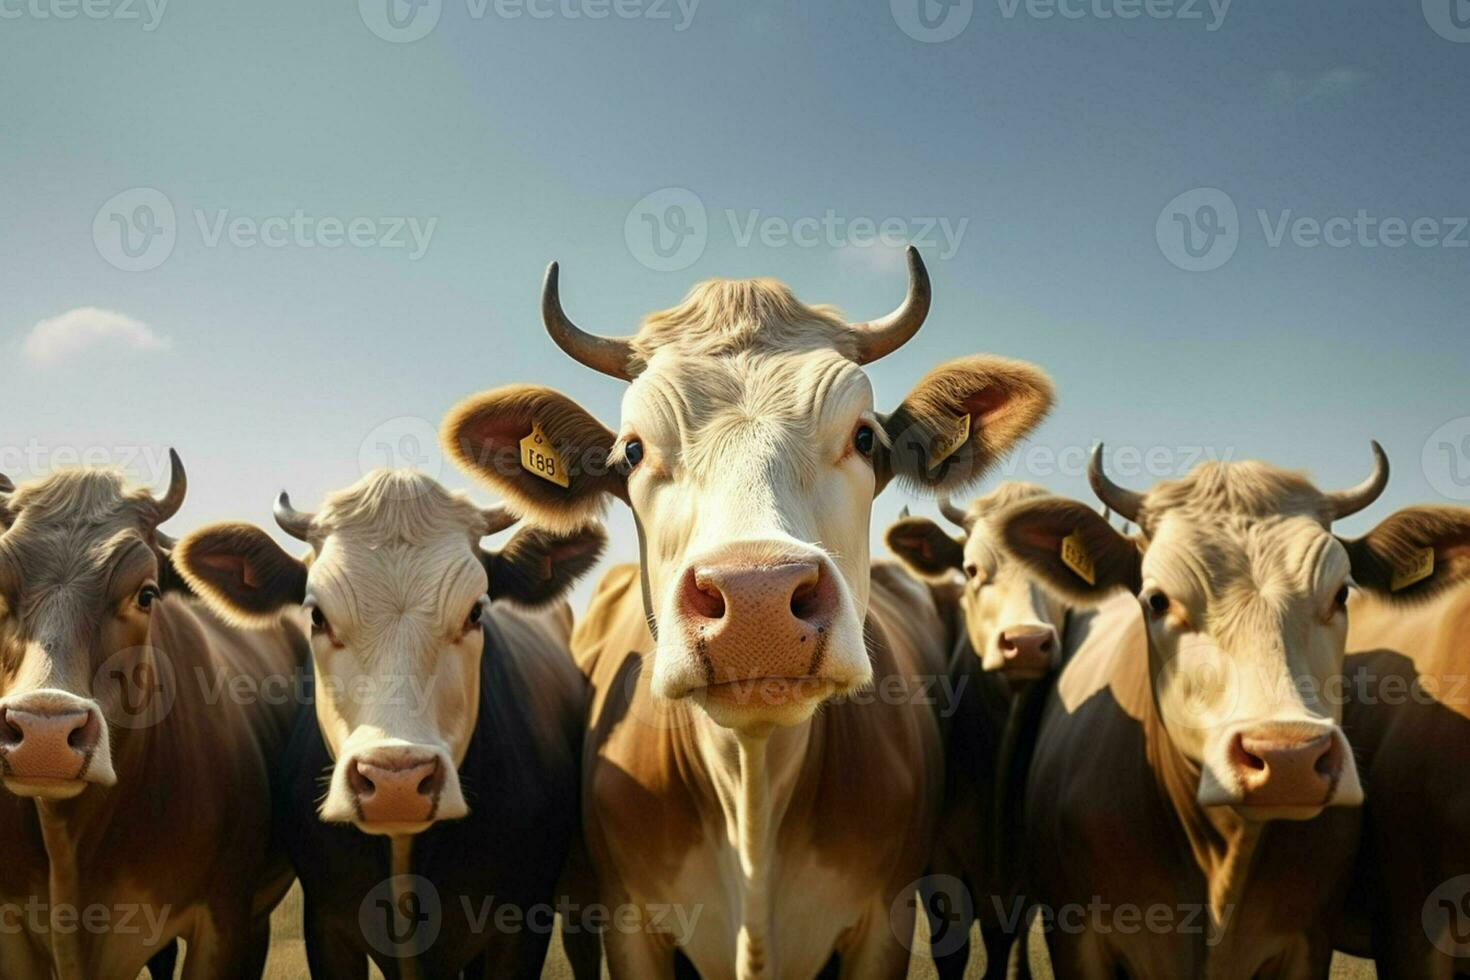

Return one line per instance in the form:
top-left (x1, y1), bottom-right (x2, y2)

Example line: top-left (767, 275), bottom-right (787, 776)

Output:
top-left (960, 517), bottom-right (1067, 680)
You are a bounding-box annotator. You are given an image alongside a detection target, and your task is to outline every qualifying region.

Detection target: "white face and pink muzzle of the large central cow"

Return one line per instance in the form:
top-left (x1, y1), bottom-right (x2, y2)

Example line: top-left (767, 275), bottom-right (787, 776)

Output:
top-left (613, 351), bottom-right (882, 727)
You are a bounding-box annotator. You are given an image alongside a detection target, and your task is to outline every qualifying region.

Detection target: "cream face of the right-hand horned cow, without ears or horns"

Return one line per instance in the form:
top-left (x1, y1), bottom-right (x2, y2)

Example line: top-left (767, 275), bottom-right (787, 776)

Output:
top-left (1141, 513), bottom-right (1363, 817)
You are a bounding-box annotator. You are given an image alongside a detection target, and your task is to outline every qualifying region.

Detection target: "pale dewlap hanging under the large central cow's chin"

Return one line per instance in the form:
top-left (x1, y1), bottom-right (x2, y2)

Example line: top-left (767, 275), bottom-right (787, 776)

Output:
top-left (695, 711), bottom-right (816, 980)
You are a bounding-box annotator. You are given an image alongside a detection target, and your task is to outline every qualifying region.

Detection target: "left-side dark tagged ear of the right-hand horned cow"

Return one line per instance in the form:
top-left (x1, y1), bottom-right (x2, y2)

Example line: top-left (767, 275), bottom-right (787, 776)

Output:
top-left (992, 498), bottom-right (1144, 605)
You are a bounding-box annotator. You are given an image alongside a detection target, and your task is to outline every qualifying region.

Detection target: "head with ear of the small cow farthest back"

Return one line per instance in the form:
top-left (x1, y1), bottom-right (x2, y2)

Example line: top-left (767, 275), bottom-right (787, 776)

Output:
top-left (885, 482), bottom-right (1067, 680)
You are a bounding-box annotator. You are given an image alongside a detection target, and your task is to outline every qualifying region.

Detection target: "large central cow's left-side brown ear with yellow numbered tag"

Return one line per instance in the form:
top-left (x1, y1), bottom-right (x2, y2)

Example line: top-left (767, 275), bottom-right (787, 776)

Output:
top-left (441, 385), bottom-right (628, 532)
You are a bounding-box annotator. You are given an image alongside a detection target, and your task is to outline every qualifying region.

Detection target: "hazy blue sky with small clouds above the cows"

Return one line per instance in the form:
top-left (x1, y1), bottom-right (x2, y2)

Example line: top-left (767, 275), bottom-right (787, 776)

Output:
top-left (0, 0), bottom-right (1470, 590)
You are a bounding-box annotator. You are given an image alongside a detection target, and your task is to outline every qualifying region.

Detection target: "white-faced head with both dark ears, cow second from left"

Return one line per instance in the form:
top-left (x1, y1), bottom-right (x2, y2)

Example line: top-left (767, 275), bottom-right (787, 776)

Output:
top-left (178, 470), bottom-right (604, 835)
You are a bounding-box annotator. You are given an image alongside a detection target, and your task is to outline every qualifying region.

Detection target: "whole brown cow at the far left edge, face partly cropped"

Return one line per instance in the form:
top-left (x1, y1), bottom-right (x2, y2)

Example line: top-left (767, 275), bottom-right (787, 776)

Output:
top-left (0, 453), bottom-right (306, 980)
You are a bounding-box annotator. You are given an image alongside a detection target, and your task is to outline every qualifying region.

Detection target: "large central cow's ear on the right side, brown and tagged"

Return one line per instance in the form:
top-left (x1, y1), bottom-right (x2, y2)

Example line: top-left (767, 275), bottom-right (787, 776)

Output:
top-left (883, 357), bottom-right (1053, 494)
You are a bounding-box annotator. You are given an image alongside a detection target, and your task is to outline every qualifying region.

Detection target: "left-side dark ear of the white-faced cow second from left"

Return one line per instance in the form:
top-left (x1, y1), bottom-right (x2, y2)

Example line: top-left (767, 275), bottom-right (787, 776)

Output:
top-left (172, 525), bottom-right (306, 626)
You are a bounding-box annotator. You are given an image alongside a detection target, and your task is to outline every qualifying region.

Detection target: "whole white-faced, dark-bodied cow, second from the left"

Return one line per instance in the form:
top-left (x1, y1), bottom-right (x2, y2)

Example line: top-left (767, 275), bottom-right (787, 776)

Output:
top-left (175, 470), bottom-right (606, 980)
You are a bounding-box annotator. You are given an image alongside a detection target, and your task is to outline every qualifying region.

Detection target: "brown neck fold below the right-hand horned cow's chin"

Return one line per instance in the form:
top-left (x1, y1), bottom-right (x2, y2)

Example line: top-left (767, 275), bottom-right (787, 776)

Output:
top-left (1144, 669), bottom-right (1263, 955)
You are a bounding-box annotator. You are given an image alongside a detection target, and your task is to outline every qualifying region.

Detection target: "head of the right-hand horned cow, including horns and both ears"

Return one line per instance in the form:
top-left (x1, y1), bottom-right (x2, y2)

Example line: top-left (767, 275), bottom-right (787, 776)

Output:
top-left (998, 442), bottom-right (1470, 818)
